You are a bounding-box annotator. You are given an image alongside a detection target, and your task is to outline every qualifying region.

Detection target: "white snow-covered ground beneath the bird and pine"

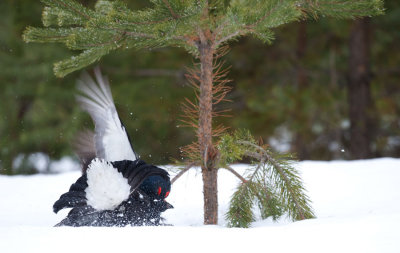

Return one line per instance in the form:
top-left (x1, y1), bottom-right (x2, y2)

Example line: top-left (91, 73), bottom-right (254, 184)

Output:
top-left (0, 158), bottom-right (400, 253)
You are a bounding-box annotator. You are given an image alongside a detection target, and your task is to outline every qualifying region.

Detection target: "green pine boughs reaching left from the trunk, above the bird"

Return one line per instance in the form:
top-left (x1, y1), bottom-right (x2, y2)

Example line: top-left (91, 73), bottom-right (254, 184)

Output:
top-left (23, 0), bottom-right (203, 77)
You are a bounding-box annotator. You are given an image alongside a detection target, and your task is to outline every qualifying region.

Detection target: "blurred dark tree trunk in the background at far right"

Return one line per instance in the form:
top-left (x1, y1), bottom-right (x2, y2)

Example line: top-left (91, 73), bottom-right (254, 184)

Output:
top-left (347, 18), bottom-right (374, 159)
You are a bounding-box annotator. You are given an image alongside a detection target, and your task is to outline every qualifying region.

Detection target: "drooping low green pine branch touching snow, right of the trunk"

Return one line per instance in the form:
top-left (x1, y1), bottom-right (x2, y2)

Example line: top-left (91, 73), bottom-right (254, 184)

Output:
top-left (222, 130), bottom-right (315, 227)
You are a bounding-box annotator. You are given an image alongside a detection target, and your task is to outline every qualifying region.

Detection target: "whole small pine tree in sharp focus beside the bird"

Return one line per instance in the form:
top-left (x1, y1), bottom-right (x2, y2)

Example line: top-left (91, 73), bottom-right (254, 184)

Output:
top-left (23, 0), bottom-right (383, 224)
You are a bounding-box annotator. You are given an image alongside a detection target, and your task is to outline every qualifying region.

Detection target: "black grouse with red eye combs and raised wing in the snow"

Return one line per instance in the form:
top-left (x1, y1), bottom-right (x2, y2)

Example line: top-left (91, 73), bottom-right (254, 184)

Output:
top-left (53, 67), bottom-right (173, 227)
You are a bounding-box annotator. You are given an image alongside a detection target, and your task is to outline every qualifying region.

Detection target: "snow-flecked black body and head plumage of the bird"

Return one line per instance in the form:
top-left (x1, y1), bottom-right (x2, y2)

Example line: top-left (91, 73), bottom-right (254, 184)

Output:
top-left (53, 159), bottom-right (173, 226)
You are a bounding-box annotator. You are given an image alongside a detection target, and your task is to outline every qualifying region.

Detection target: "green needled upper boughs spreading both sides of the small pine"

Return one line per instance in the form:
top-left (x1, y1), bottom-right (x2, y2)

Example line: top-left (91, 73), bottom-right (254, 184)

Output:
top-left (24, 0), bottom-right (383, 76)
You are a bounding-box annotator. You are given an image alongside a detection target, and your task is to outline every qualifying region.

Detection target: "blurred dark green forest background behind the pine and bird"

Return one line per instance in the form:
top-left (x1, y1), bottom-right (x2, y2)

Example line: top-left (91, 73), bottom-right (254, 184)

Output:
top-left (0, 0), bottom-right (400, 174)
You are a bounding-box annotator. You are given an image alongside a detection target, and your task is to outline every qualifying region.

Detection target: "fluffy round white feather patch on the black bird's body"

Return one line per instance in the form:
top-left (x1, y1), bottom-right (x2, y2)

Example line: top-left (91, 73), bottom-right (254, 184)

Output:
top-left (85, 158), bottom-right (131, 210)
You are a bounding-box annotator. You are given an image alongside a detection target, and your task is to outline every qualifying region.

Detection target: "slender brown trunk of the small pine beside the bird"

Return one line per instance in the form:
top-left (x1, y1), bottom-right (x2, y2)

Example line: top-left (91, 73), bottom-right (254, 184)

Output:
top-left (197, 41), bottom-right (218, 224)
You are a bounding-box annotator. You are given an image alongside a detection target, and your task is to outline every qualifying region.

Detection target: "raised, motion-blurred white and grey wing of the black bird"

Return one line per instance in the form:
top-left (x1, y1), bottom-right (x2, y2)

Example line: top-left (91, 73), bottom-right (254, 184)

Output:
top-left (77, 68), bottom-right (137, 161)
